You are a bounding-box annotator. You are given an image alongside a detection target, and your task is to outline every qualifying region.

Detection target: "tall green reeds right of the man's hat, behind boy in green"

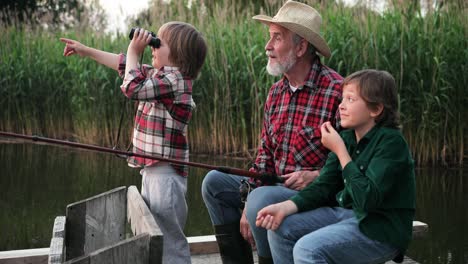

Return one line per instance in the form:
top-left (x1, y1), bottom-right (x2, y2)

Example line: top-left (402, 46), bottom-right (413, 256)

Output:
top-left (324, 4), bottom-right (468, 164)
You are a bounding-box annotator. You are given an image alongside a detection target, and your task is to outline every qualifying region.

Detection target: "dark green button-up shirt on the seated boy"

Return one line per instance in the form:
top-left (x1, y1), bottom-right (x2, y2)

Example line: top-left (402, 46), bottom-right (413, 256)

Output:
top-left (291, 126), bottom-right (415, 253)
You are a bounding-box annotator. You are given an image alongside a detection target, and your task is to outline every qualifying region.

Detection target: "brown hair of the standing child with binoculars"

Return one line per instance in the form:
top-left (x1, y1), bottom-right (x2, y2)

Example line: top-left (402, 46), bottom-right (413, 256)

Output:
top-left (159, 21), bottom-right (207, 79)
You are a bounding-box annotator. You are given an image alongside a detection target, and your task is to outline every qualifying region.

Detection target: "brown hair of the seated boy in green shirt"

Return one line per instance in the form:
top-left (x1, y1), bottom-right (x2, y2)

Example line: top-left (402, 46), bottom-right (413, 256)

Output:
top-left (341, 69), bottom-right (400, 128)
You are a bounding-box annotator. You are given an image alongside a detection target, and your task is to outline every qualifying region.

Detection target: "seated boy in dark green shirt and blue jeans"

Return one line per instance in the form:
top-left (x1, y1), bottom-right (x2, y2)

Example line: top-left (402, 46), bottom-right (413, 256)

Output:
top-left (254, 70), bottom-right (415, 264)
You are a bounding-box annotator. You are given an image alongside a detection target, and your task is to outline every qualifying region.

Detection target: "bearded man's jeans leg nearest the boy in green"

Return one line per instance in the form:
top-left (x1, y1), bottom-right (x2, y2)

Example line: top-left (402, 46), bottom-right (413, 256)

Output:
top-left (246, 186), bottom-right (297, 256)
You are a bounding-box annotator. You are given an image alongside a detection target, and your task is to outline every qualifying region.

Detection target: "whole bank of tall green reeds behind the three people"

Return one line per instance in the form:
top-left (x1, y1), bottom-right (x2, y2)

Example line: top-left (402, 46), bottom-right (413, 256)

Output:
top-left (0, 0), bottom-right (468, 164)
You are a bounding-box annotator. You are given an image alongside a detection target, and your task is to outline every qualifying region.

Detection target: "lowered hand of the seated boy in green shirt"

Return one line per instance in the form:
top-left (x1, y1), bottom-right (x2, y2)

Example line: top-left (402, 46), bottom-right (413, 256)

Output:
top-left (255, 200), bottom-right (298, 230)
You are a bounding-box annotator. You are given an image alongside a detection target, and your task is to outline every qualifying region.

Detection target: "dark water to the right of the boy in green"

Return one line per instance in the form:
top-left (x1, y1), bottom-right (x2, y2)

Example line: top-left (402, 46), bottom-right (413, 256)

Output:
top-left (409, 169), bottom-right (468, 264)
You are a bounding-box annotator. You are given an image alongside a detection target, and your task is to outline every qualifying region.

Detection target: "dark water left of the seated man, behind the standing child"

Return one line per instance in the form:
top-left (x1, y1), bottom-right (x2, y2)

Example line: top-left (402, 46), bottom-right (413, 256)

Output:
top-left (0, 143), bottom-right (248, 251)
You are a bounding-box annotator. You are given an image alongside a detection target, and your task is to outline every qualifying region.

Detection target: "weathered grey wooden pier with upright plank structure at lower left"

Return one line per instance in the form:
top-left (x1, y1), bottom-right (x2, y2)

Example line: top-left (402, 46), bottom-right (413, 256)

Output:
top-left (0, 186), bottom-right (428, 264)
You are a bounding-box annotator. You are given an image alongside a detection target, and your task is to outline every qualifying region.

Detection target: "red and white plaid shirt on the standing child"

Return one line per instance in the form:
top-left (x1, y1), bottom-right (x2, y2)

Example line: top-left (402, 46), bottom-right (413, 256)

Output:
top-left (119, 54), bottom-right (195, 177)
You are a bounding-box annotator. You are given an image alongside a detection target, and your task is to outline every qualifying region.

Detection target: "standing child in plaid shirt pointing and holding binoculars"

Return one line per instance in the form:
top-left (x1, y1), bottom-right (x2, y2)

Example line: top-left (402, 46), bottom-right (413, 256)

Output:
top-left (60, 22), bottom-right (207, 264)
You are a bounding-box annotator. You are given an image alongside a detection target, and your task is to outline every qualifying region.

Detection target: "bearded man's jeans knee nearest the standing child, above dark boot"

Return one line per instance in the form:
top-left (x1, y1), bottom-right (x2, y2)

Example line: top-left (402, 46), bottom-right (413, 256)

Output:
top-left (202, 170), bottom-right (248, 225)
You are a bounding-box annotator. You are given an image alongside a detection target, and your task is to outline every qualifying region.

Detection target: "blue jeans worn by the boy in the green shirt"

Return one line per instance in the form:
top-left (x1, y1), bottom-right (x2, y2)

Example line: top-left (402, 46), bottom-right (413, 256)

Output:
top-left (268, 207), bottom-right (398, 264)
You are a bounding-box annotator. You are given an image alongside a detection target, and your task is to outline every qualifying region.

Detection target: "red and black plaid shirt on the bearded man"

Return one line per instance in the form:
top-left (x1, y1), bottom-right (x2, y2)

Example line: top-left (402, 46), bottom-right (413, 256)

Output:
top-left (252, 58), bottom-right (343, 175)
